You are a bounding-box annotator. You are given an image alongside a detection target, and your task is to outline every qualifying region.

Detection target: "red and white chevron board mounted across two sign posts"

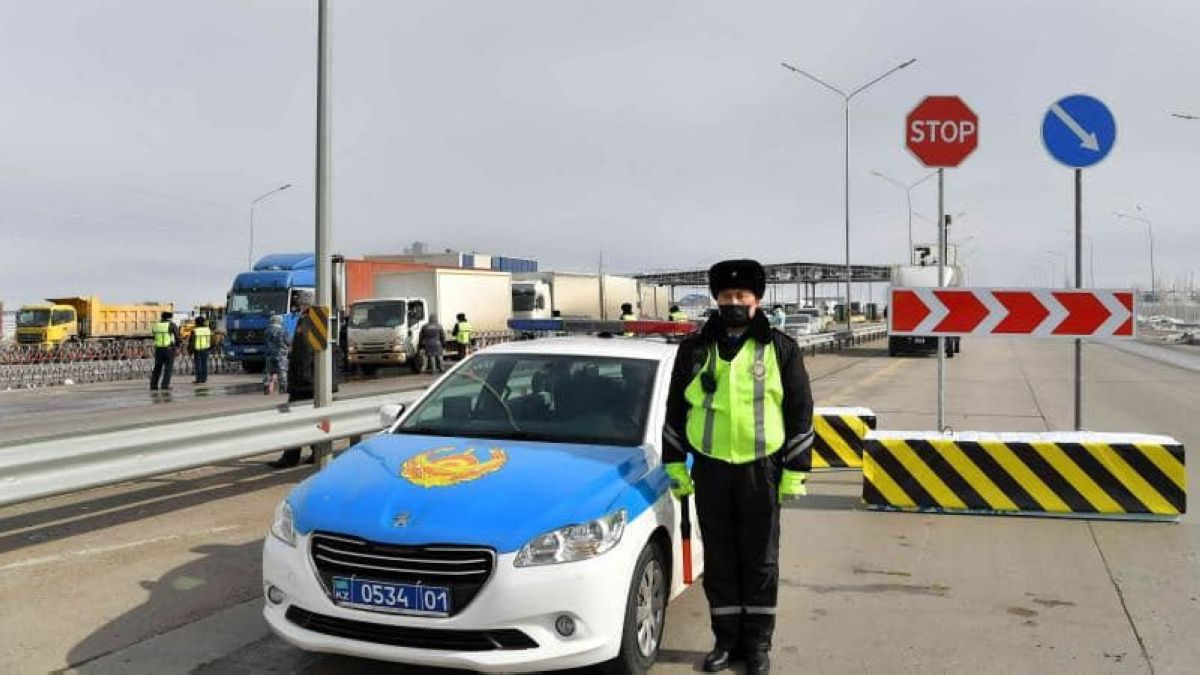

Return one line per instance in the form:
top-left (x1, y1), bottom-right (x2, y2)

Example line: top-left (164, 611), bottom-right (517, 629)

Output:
top-left (888, 288), bottom-right (1136, 339)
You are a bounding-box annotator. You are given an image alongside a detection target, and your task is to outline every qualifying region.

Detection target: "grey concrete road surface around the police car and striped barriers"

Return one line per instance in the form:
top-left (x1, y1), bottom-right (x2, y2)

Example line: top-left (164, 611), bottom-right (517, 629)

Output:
top-left (0, 341), bottom-right (1200, 674)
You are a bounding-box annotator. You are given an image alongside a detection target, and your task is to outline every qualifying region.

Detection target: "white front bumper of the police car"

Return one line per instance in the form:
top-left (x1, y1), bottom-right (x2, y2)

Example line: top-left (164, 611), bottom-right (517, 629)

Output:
top-left (263, 531), bottom-right (641, 673)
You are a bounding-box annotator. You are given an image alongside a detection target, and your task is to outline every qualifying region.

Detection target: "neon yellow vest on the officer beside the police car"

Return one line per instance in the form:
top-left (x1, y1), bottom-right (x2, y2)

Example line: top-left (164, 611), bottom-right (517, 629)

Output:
top-left (684, 338), bottom-right (787, 464)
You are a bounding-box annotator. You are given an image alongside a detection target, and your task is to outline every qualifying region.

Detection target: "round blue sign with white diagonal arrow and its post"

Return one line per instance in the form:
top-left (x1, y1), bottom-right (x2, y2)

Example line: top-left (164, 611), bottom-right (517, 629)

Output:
top-left (1042, 94), bottom-right (1117, 431)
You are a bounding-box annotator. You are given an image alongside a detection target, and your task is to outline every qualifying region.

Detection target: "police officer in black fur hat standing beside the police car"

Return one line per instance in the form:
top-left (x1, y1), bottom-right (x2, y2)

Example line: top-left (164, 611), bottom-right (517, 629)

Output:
top-left (662, 259), bottom-right (812, 674)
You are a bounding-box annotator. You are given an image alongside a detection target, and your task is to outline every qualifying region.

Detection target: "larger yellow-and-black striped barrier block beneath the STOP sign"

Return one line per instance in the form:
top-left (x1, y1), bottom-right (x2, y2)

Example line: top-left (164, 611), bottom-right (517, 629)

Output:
top-left (863, 431), bottom-right (1187, 520)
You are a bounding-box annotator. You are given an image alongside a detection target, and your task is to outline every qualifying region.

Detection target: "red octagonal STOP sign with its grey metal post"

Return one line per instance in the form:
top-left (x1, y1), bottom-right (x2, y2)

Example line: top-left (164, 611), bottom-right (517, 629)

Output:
top-left (889, 96), bottom-right (979, 431)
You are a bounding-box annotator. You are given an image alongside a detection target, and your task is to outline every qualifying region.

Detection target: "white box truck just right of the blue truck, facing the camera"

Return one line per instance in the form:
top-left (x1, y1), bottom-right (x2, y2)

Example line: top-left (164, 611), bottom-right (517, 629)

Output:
top-left (347, 268), bottom-right (512, 375)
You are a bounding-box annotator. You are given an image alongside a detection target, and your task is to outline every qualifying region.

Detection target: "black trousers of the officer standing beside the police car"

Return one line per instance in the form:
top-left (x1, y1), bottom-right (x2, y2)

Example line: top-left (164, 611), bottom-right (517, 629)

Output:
top-left (691, 453), bottom-right (782, 650)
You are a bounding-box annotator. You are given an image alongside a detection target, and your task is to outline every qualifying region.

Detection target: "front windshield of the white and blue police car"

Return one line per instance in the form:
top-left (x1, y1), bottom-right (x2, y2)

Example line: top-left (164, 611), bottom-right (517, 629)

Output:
top-left (397, 353), bottom-right (658, 446)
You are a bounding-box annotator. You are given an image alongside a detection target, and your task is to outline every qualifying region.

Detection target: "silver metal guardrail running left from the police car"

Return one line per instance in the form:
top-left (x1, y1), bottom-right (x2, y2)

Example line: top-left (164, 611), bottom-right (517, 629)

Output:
top-left (0, 390), bottom-right (420, 506)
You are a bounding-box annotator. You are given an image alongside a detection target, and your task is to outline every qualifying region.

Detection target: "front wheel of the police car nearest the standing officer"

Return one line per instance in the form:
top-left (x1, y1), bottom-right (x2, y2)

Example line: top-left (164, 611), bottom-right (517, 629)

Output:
top-left (598, 542), bottom-right (670, 675)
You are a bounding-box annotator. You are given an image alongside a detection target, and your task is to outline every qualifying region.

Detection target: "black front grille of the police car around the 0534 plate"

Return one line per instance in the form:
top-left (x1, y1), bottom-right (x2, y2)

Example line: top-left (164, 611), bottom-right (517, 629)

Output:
top-left (310, 532), bottom-right (496, 615)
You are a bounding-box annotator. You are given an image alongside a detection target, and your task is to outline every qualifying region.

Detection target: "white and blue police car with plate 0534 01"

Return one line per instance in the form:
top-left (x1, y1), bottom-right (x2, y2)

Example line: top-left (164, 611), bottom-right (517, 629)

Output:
top-left (263, 324), bottom-right (702, 673)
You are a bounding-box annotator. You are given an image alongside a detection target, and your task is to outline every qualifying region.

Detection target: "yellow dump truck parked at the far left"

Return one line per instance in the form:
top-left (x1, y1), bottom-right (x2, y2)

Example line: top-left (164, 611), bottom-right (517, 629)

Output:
top-left (17, 295), bottom-right (174, 347)
